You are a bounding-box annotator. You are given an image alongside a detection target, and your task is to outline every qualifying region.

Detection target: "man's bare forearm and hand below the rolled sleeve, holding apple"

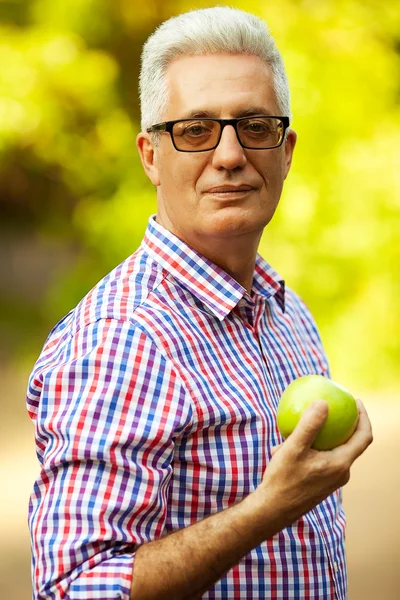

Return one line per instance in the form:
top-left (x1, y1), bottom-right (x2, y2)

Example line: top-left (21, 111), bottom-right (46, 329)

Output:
top-left (131, 400), bottom-right (372, 600)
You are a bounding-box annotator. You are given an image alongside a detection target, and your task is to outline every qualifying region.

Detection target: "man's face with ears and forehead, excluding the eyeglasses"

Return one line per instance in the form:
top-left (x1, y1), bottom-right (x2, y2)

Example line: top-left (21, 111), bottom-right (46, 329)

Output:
top-left (138, 54), bottom-right (296, 247)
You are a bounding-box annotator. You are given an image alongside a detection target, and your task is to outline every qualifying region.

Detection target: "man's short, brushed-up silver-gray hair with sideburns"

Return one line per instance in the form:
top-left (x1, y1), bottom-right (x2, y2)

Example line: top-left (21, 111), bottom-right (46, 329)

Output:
top-left (139, 6), bottom-right (291, 137)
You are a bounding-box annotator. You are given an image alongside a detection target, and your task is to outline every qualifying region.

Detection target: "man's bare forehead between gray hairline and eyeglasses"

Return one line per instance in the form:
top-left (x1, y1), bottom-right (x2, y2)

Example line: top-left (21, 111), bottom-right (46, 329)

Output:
top-left (164, 54), bottom-right (279, 120)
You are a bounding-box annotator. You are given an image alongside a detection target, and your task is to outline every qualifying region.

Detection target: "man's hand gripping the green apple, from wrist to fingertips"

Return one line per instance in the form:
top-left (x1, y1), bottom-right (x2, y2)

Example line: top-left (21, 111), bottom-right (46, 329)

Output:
top-left (255, 400), bottom-right (373, 529)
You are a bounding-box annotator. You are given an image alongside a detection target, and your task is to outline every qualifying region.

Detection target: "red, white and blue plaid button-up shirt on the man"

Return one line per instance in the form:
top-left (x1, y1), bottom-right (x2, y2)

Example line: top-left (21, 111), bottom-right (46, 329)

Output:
top-left (27, 217), bottom-right (347, 600)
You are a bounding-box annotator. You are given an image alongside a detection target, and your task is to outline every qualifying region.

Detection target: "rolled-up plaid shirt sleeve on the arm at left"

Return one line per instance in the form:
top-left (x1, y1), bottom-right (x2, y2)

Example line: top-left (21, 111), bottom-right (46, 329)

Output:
top-left (28, 319), bottom-right (192, 600)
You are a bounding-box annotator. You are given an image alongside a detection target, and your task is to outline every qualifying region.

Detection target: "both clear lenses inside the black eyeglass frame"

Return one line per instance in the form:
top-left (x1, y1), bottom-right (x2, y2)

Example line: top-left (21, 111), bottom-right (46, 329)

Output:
top-left (172, 117), bottom-right (284, 151)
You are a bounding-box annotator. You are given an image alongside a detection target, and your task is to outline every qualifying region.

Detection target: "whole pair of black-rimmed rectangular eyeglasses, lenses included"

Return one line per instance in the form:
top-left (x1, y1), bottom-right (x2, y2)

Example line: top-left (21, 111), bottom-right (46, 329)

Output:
top-left (147, 116), bottom-right (289, 152)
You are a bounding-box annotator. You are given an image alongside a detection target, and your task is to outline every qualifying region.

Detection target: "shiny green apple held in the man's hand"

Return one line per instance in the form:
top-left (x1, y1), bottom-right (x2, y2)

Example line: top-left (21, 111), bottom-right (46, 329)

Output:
top-left (277, 375), bottom-right (358, 450)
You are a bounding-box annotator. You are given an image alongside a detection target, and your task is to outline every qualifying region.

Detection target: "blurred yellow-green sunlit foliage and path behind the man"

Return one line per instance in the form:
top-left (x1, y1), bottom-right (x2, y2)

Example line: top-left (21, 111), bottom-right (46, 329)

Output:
top-left (0, 0), bottom-right (400, 600)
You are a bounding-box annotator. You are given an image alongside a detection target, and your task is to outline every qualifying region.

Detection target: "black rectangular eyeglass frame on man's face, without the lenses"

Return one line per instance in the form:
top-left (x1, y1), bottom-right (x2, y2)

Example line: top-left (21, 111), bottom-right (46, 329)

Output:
top-left (146, 115), bottom-right (290, 152)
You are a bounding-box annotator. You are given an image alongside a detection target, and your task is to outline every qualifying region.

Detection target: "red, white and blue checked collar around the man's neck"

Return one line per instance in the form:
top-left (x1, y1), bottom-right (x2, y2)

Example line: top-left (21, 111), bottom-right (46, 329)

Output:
top-left (142, 215), bottom-right (285, 321)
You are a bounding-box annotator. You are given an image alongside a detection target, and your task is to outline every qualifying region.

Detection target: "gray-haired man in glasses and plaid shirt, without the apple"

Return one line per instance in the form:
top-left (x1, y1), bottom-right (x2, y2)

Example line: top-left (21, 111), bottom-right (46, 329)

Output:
top-left (28, 7), bottom-right (372, 600)
